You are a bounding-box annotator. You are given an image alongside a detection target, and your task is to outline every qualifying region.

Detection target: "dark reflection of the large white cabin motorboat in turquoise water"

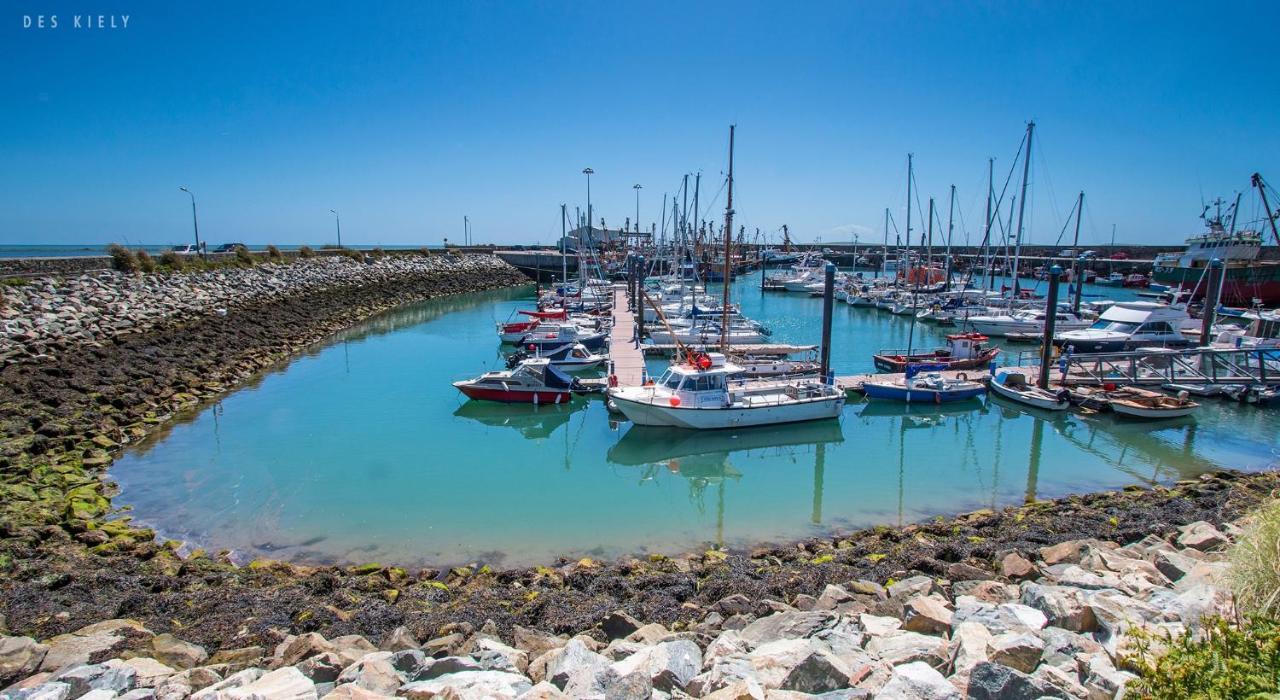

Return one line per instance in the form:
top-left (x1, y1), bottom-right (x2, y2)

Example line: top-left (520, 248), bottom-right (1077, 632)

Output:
top-left (608, 420), bottom-right (845, 546)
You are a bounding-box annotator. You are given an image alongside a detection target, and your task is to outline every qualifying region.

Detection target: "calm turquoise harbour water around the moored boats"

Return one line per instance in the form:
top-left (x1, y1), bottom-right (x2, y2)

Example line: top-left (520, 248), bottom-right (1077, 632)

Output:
top-left (111, 273), bottom-right (1280, 567)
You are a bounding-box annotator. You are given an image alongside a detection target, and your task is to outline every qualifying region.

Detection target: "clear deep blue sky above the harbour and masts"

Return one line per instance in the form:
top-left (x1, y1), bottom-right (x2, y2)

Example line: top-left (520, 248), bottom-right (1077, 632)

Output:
top-left (0, 0), bottom-right (1280, 244)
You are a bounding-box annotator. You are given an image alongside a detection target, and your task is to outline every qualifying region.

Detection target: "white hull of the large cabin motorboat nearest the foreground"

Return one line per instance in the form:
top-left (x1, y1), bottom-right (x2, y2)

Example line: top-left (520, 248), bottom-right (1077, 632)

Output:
top-left (611, 394), bottom-right (845, 430)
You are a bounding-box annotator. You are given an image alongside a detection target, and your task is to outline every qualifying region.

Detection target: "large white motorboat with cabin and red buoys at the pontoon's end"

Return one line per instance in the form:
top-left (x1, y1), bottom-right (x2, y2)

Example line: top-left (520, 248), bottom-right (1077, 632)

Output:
top-left (608, 353), bottom-right (845, 430)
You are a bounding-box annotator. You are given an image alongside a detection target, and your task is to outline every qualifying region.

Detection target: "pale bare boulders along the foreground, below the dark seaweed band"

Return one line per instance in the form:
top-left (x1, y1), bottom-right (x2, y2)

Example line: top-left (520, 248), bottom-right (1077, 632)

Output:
top-left (0, 521), bottom-right (1234, 700)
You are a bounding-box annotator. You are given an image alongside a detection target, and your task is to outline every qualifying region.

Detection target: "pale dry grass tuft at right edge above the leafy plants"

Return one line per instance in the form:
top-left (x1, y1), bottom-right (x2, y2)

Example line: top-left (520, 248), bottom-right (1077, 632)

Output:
top-left (1230, 500), bottom-right (1280, 616)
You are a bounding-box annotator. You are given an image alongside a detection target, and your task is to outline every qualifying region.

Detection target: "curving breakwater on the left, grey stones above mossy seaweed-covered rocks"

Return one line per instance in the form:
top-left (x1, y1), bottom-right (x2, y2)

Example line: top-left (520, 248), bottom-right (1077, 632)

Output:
top-left (0, 255), bottom-right (527, 552)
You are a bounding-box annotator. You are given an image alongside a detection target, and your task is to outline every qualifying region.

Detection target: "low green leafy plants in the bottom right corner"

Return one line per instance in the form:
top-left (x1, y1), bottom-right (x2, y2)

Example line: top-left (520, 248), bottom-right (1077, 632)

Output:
top-left (1125, 616), bottom-right (1280, 700)
